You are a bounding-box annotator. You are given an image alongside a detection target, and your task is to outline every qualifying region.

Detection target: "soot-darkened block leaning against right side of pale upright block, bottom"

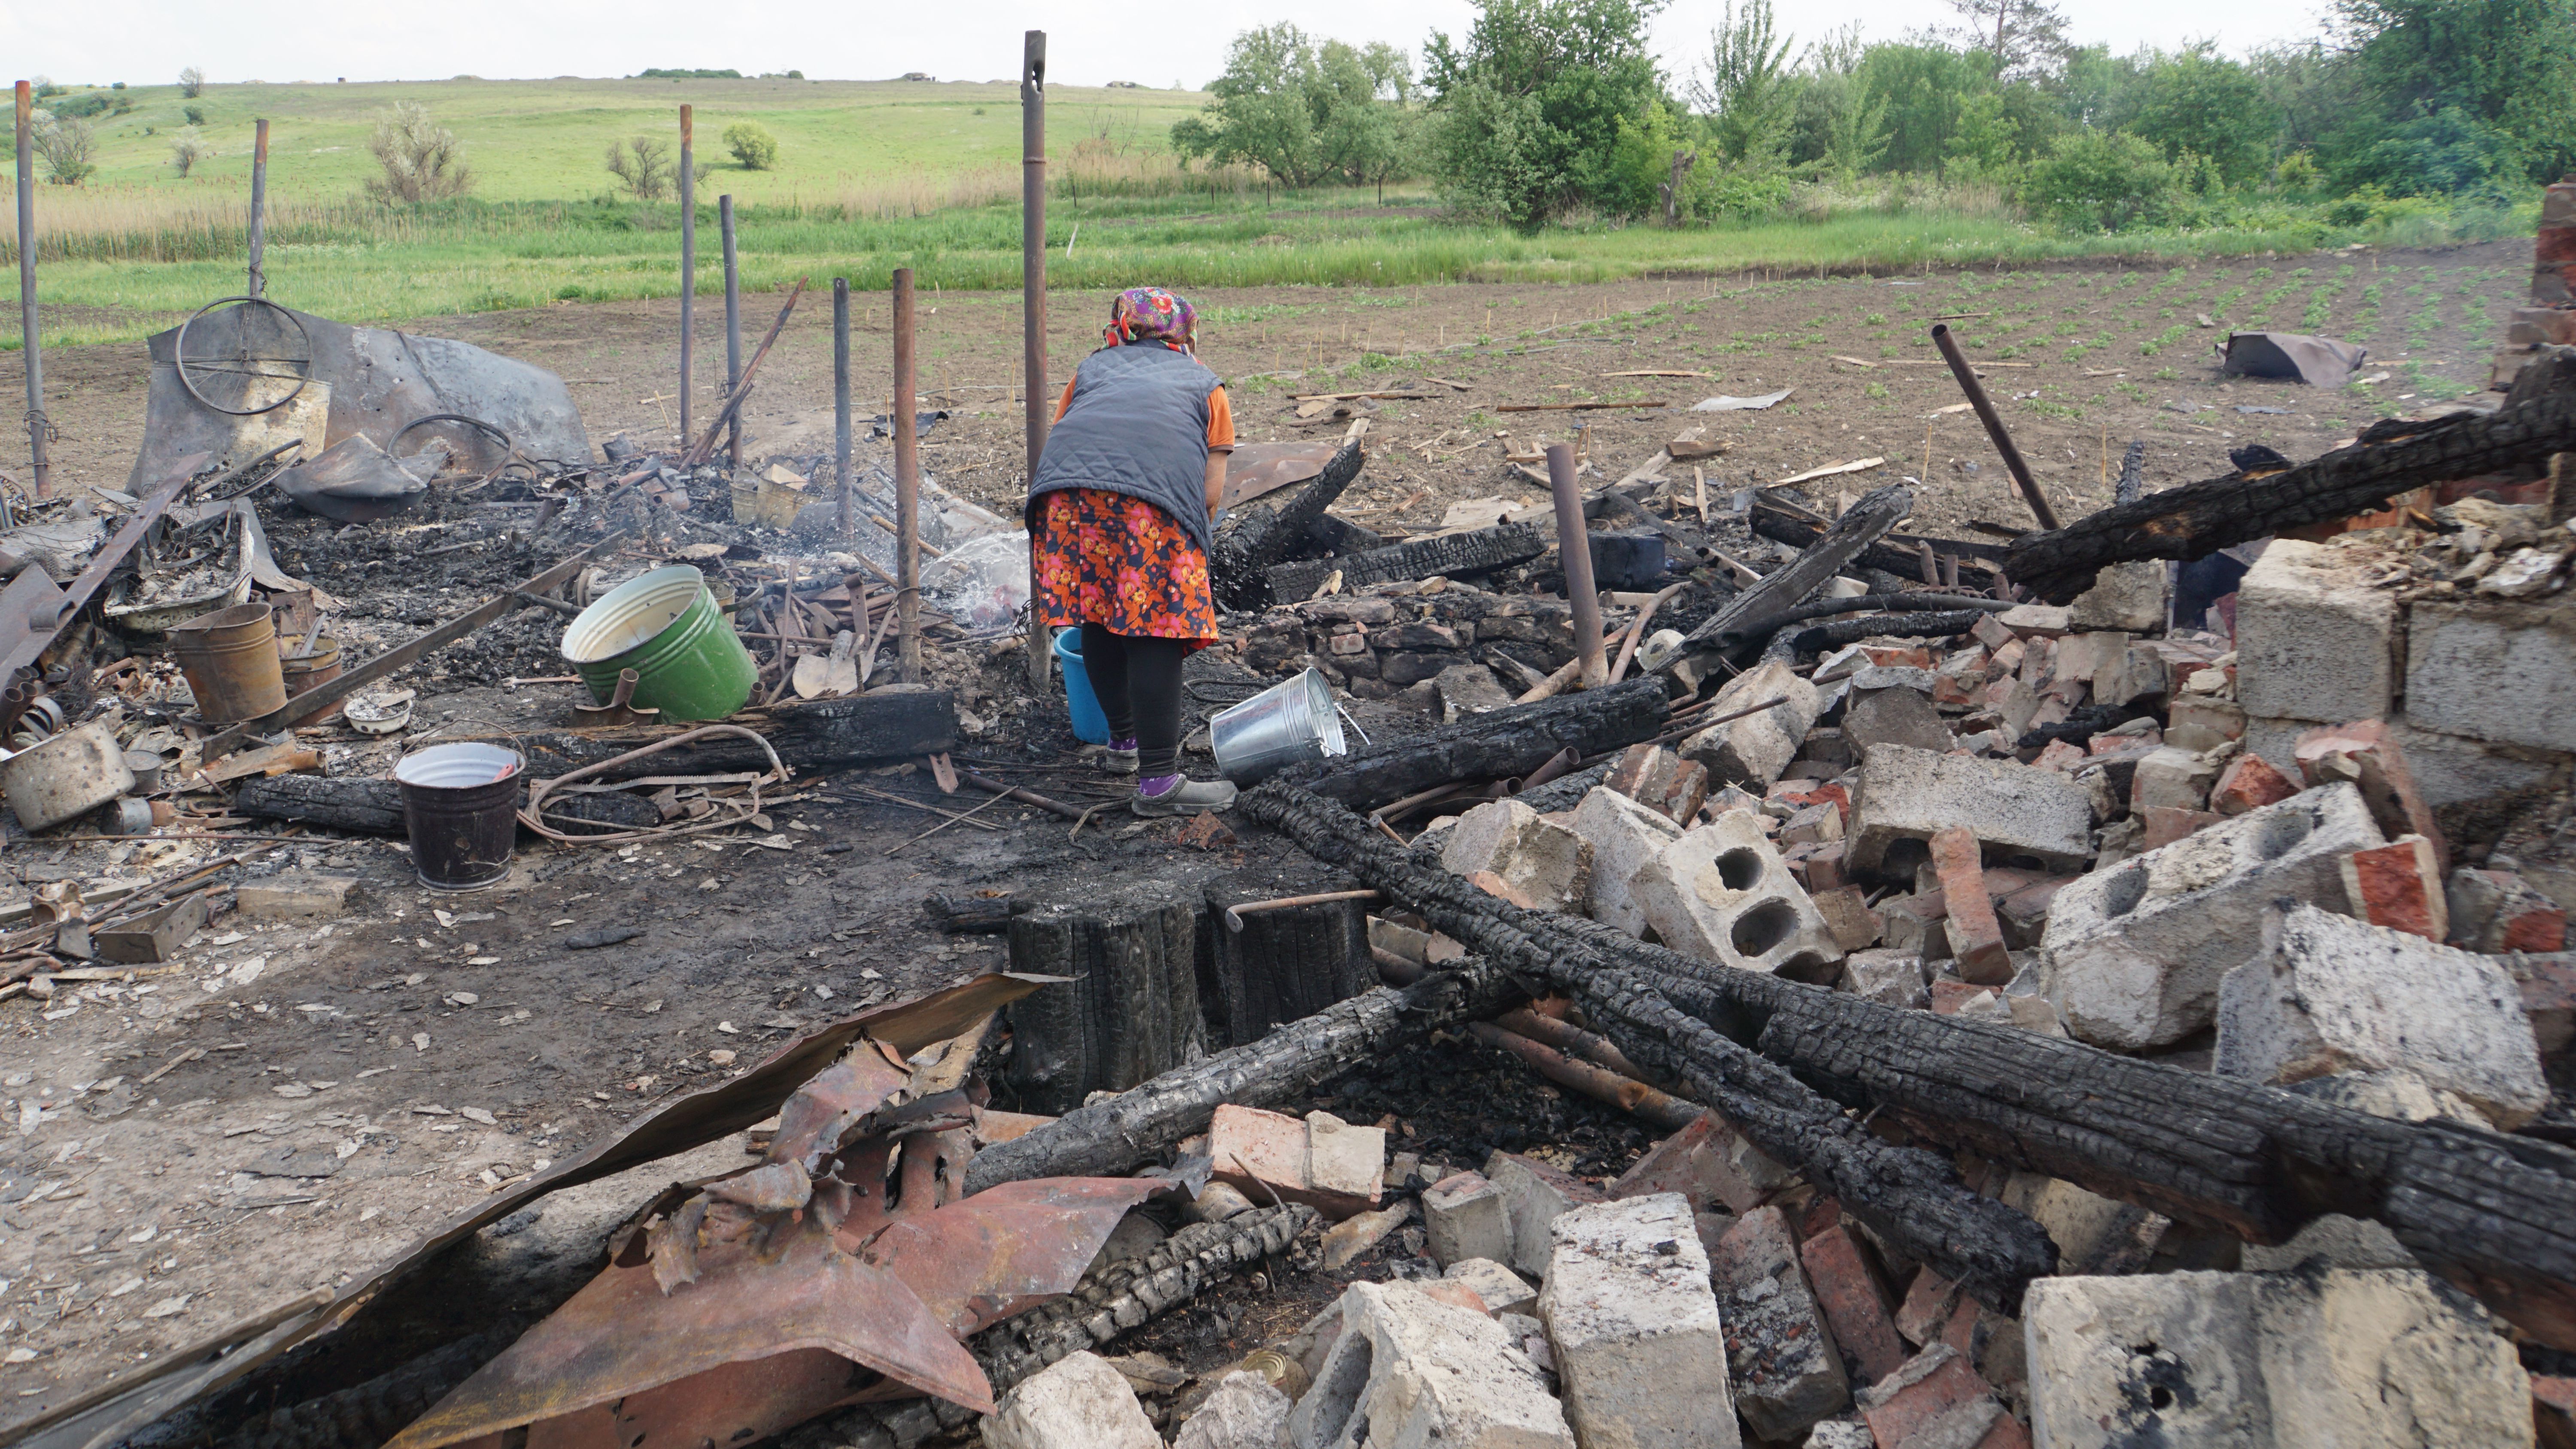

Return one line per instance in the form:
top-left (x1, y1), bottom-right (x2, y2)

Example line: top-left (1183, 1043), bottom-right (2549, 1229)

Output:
top-left (1713, 1207), bottom-right (1855, 1444)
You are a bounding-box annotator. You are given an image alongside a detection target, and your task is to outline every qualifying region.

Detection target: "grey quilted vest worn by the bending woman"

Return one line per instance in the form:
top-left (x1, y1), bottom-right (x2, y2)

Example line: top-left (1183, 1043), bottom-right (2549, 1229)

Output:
top-left (1023, 343), bottom-right (1218, 553)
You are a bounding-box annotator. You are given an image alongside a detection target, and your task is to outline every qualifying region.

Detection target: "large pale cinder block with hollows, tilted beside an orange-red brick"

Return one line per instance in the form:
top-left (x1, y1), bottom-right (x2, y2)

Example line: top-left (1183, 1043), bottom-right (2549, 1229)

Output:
top-left (2040, 785), bottom-right (2388, 1050)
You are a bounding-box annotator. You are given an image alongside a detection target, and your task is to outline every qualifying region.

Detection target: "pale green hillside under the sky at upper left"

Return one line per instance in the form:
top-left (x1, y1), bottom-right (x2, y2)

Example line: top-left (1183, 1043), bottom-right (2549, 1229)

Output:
top-left (0, 77), bottom-right (1208, 206)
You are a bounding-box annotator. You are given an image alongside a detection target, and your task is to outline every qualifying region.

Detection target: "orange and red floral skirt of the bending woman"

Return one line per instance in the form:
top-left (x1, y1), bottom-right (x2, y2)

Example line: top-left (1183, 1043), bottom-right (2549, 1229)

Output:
top-left (1030, 489), bottom-right (1216, 649)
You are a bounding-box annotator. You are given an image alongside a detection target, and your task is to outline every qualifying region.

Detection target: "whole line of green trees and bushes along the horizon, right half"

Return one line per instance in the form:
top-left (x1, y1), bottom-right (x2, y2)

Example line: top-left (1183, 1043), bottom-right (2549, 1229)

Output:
top-left (1172, 0), bottom-right (2576, 229)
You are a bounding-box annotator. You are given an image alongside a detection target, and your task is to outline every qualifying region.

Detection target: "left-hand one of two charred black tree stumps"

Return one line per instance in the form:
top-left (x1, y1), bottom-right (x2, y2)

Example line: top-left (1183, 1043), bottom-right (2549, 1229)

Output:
top-left (1010, 883), bottom-right (1198, 1114)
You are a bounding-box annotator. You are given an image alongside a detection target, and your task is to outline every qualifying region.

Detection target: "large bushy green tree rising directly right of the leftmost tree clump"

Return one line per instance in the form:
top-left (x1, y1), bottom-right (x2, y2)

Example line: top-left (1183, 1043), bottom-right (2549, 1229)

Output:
top-left (1425, 0), bottom-right (1664, 232)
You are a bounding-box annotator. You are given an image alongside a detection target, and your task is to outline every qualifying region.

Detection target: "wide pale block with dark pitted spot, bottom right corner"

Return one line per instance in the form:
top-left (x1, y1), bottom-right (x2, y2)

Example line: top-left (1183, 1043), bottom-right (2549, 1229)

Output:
top-left (2020, 1269), bottom-right (2532, 1449)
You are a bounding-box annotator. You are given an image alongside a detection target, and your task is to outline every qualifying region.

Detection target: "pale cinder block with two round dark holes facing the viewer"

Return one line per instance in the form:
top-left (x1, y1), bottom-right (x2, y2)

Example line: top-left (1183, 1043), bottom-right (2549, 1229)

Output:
top-left (1628, 811), bottom-right (1842, 981)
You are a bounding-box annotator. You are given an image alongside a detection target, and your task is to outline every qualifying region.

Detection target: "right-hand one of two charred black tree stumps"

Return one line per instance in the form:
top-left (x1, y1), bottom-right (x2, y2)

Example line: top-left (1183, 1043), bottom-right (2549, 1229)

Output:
top-left (1206, 862), bottom-right (1378, 1048)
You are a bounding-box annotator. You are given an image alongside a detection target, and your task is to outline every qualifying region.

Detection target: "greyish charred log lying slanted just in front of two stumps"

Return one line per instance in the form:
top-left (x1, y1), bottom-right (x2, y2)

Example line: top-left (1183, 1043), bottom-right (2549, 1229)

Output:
top-left (966, 957), bottom-right (1528, 1191)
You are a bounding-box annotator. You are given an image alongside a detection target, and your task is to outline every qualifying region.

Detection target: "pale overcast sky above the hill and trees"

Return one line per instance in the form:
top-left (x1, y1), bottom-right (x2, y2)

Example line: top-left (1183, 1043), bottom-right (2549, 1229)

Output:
top-left (0, 0), bottom-right (2321, 96)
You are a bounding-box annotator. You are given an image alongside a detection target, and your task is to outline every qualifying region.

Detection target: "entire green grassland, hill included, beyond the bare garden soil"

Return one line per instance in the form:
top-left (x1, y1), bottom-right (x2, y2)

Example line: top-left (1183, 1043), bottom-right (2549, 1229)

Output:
top-left (0, 80), bottom-right (2532, 348)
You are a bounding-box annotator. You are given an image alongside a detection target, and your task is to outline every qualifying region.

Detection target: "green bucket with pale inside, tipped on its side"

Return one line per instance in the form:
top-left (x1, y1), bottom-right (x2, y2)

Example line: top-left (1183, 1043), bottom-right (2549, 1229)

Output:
top-left (564, 564), bottom-right (760, 721)
